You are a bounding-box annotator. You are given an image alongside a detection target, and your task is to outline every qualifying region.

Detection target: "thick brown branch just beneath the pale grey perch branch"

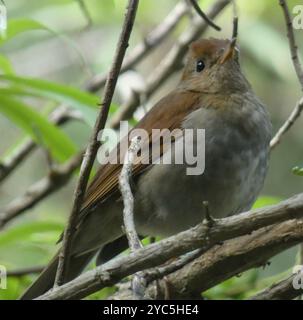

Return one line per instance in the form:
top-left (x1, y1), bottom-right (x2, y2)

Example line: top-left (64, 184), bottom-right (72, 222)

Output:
top-left (111, 219), bottom-right (303, 300)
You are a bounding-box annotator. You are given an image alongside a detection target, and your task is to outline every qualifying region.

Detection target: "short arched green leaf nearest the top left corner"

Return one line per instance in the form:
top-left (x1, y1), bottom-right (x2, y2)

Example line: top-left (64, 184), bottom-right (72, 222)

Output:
top-left (0, 19), bottom-right (51, 46)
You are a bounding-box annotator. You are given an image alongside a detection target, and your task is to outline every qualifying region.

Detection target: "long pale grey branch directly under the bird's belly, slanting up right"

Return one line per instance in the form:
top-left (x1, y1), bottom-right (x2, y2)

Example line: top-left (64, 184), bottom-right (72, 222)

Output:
top-left (38, 194), bottom-right (303, 299)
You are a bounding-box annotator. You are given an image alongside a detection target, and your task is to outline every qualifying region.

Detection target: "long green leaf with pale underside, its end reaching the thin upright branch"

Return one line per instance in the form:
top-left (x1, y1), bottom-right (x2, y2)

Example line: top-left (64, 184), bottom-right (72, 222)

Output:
top-left (0, 75), bottom-right (99, 127)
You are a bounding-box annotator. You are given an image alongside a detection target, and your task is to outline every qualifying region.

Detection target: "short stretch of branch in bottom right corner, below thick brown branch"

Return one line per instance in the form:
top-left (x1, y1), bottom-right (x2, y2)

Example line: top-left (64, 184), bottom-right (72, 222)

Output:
top-left (249, 274), bottom-right (303, 300)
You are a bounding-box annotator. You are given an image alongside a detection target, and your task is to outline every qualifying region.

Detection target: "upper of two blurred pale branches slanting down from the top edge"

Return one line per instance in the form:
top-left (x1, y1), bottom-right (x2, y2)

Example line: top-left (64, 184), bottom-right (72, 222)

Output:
top-left (87, 1), bottom-right (188, 91)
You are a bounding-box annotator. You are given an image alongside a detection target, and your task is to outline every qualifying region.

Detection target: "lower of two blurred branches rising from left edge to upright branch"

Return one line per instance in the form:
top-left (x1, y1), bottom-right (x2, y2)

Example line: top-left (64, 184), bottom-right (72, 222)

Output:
top-left (0, 152), bottom-right (82, 230)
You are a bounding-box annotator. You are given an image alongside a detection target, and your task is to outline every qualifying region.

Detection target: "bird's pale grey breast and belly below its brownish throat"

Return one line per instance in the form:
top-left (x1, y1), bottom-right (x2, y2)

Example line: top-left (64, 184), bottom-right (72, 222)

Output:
top-left (136, 99), bottom-right (270, 236)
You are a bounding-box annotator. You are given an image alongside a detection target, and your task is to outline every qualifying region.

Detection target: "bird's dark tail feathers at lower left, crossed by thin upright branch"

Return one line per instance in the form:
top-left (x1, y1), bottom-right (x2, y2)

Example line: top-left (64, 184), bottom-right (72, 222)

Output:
top-left (20, 252), bottom-right (95, 300)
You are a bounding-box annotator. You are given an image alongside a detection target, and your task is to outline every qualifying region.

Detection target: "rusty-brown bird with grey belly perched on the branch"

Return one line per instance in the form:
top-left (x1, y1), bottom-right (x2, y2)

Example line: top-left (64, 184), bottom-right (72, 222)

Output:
top-left (21, 38), bottom-right (272, 299)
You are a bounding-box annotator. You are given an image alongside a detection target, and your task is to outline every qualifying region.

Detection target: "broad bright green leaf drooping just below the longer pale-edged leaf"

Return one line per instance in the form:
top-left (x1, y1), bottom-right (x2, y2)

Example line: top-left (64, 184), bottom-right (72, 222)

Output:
top-left (0, 93), bottom-right (77, 161)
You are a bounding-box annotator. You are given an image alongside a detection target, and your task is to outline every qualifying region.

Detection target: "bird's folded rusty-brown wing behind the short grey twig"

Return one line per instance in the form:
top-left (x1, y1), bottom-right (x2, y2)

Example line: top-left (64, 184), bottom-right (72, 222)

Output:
top-left (82, 90), bottom-right (201, 215)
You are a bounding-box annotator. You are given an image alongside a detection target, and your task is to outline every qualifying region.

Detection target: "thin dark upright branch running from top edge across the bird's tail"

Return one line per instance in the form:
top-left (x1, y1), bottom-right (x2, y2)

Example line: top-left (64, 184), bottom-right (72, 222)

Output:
top-left (55, 0), bottom-right (139, 286)
